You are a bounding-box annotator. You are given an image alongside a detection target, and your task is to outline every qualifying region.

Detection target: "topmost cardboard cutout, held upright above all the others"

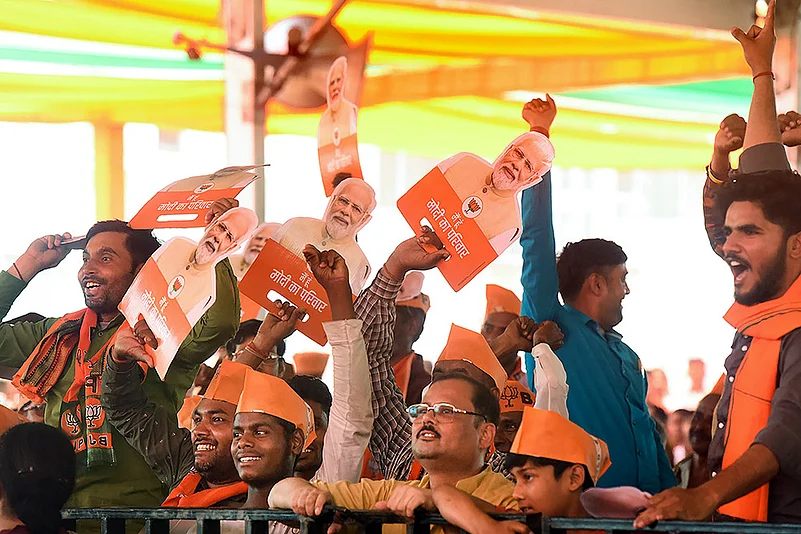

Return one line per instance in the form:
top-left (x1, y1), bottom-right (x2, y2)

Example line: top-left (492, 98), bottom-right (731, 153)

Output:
top-left (317, 56), bottom-right (362, 197)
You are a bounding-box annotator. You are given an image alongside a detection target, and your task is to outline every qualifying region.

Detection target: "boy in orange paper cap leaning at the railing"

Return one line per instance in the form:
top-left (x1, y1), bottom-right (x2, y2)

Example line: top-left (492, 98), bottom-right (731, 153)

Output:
top-left (433, 407), bottom-right (612, 533)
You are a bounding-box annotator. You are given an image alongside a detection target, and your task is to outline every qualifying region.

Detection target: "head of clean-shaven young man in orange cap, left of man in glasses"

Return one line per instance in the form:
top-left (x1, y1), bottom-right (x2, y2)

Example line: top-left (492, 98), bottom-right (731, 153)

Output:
top-left (231, 369), bottom-right (314, 508)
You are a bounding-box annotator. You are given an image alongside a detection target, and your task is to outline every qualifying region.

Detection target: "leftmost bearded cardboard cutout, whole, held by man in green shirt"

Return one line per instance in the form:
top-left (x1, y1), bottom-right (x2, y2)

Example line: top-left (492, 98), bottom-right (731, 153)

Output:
top-left (119, 208), bottom-right (258, 380)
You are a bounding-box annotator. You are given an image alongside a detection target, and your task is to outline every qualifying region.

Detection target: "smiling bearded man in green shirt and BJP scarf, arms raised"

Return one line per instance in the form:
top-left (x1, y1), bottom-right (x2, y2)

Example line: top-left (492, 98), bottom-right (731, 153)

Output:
top-left (0, 200), bottom-right (237, 507)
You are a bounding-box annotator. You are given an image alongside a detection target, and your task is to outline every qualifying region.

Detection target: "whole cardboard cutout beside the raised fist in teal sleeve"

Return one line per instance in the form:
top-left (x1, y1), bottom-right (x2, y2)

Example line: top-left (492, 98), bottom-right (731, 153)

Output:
top-left (398, 132), bottom-right (554, 291)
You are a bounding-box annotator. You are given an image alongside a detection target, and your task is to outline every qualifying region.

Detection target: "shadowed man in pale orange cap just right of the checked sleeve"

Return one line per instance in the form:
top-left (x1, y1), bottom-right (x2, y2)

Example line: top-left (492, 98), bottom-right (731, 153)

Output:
top-left (391, 271), bottom-right (431, 404)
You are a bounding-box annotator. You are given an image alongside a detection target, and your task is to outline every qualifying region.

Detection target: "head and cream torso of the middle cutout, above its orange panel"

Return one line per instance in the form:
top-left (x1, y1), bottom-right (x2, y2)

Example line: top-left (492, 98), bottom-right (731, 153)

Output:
top-left (273, 178), bottom-right (376, 295)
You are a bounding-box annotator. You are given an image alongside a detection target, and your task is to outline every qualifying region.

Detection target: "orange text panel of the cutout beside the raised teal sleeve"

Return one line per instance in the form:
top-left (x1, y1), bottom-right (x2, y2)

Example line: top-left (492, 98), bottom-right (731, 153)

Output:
top-left (397, 167), bottom-right (498, 291)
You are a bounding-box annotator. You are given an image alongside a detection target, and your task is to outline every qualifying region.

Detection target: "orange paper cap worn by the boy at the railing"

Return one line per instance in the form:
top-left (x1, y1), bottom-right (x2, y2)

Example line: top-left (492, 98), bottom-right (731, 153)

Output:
top-left (509, 407), bottom-right (612, 483)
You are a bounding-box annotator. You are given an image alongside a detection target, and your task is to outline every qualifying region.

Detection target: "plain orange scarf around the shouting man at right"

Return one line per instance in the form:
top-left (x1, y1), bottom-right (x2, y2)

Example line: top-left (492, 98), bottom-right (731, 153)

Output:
top-left (719, 277), bottom-right (801, 522)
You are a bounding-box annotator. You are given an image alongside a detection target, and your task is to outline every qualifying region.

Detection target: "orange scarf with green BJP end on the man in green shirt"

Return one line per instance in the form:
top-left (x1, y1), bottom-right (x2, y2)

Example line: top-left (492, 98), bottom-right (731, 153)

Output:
top-left (12, 309), bottom-right (116, 468)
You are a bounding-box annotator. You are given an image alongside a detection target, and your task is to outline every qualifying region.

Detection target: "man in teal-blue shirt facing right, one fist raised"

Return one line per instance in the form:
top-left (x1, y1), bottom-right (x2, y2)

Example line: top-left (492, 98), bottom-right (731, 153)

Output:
top-left (520, 92), bottom-right (676, 493)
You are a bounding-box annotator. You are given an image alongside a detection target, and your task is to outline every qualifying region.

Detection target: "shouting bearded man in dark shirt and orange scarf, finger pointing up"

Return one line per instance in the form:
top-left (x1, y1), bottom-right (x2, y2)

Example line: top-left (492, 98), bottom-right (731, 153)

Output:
top-left (635, 2), bottom-right (801, 528)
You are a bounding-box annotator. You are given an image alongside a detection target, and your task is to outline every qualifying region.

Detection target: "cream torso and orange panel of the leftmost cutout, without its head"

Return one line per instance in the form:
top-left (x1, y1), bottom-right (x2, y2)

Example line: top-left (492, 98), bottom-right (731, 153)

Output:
top-left (119, 237), bottom-right (216, 380)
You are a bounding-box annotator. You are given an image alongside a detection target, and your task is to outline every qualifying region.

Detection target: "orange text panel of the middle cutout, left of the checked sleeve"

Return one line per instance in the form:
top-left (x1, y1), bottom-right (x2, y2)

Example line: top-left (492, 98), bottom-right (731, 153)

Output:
top-left (239, 238), bottom-right (331, 346)
